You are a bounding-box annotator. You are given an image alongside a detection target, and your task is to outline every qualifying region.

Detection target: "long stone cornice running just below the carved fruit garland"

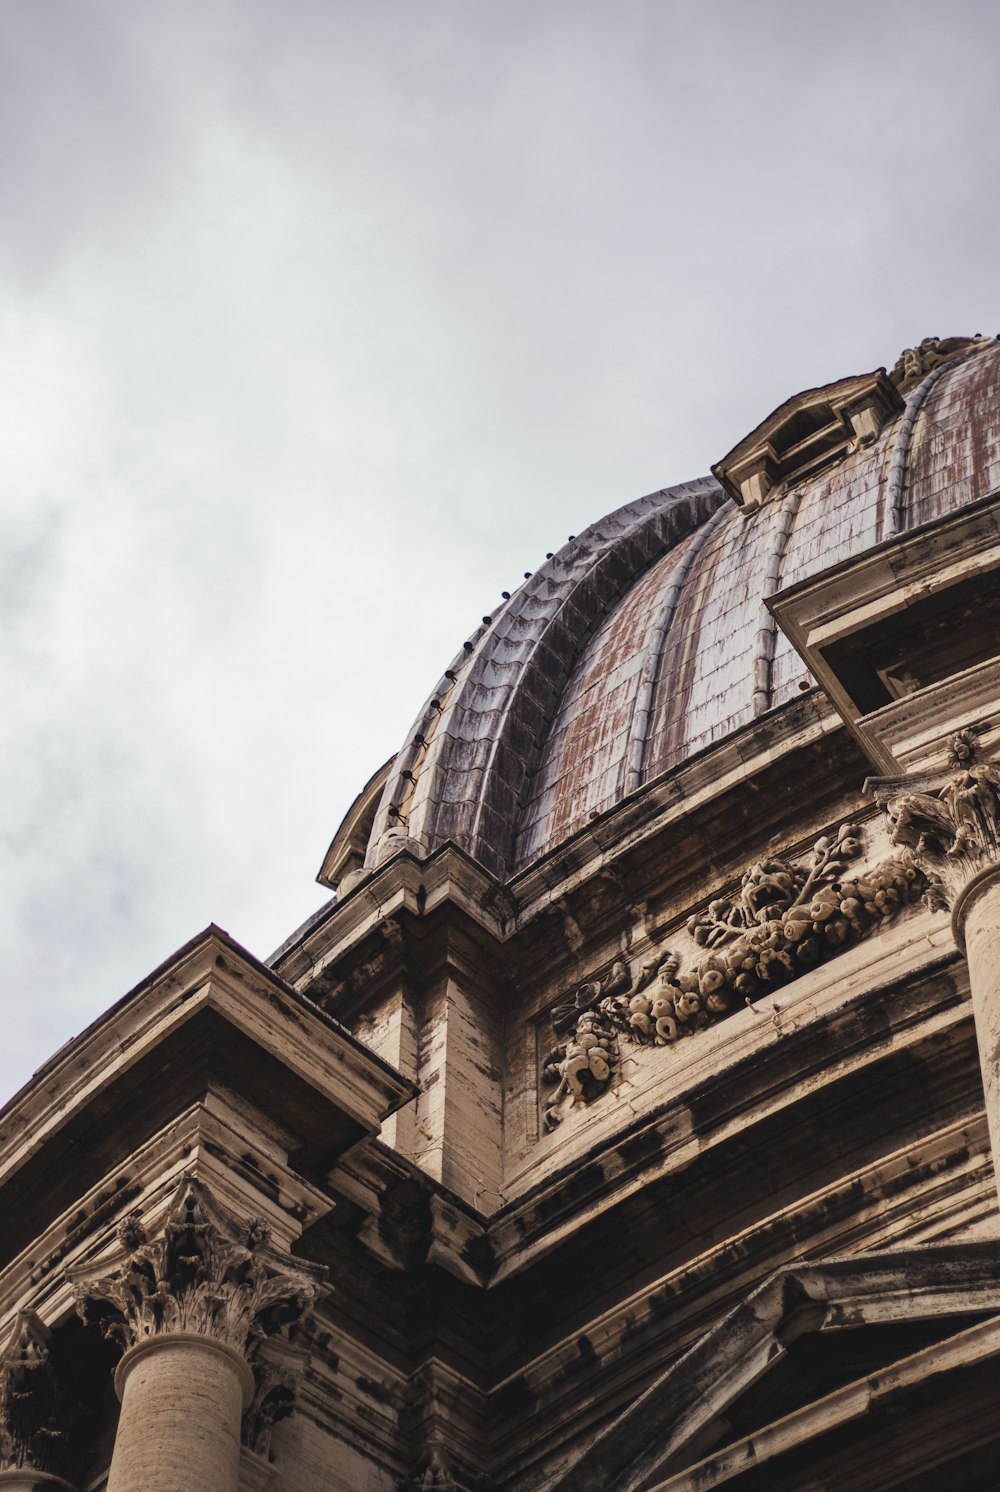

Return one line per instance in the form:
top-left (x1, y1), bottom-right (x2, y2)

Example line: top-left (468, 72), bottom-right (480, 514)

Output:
top-left (490, 912), bottom-right (972, 1283)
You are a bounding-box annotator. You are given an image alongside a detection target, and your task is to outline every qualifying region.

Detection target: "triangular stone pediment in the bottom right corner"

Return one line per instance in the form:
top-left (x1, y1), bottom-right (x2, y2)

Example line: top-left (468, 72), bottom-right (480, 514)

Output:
top-left (546, 1241), bottom-right (1000, 1492)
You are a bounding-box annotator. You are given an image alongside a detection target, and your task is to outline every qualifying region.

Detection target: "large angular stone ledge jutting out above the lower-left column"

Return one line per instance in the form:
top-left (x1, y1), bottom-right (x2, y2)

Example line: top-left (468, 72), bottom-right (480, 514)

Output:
top-left (0, 927), bottom-right (416, 1270)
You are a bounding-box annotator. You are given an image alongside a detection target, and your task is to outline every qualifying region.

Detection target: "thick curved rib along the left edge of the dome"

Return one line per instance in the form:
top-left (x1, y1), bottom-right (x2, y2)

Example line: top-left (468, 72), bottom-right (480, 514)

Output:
top-left (367, 477), bottom-right (730, 876)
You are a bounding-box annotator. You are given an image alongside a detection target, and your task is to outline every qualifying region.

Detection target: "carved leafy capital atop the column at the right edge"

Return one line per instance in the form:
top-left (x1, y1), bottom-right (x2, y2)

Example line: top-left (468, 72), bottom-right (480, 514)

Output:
top-left (866, 731), bottom-right (1000, 907)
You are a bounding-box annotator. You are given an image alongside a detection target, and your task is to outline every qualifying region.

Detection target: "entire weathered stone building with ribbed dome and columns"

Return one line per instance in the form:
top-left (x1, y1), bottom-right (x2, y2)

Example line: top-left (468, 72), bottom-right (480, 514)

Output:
top-left (0, 339), bottom-right (1000, 1492)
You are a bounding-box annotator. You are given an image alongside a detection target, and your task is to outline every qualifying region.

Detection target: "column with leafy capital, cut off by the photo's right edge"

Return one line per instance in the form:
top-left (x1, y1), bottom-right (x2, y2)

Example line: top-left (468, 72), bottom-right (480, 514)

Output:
top-left (866, 730), bottom-right (1000, 1192)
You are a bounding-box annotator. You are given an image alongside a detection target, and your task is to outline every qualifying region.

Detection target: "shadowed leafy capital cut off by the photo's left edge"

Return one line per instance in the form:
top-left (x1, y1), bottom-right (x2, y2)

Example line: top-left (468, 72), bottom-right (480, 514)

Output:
top-left (0, 1310), bottom-right (79, 1480)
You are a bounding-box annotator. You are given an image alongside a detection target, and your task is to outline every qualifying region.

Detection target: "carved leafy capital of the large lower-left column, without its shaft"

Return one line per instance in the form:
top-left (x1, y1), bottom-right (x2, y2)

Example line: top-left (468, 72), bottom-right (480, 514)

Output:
top-left (75, 1176), bottom-right (325, 1358)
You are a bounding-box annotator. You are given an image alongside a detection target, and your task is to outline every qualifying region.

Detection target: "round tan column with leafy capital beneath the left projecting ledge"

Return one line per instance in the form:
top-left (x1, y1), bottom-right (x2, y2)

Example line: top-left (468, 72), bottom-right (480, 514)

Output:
top-left (76, 1177), bottom-right (322, 1492)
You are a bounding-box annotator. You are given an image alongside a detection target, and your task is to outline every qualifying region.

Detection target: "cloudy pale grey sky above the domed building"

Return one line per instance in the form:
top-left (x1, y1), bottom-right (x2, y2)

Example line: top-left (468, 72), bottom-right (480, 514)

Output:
top-left (0, 0), bottom-right (1000, 1097)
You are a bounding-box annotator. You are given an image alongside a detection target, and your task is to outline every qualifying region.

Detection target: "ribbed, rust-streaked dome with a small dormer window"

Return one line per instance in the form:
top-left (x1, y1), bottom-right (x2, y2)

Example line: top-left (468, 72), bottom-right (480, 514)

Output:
top-left (337, 337), bottom-right (1000, 883)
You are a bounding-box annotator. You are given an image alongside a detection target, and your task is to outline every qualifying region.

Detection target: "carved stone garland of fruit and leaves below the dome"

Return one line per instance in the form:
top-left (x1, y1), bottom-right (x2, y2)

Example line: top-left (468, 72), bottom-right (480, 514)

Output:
top-left (542, 824), bottom-right (927, 1129)
